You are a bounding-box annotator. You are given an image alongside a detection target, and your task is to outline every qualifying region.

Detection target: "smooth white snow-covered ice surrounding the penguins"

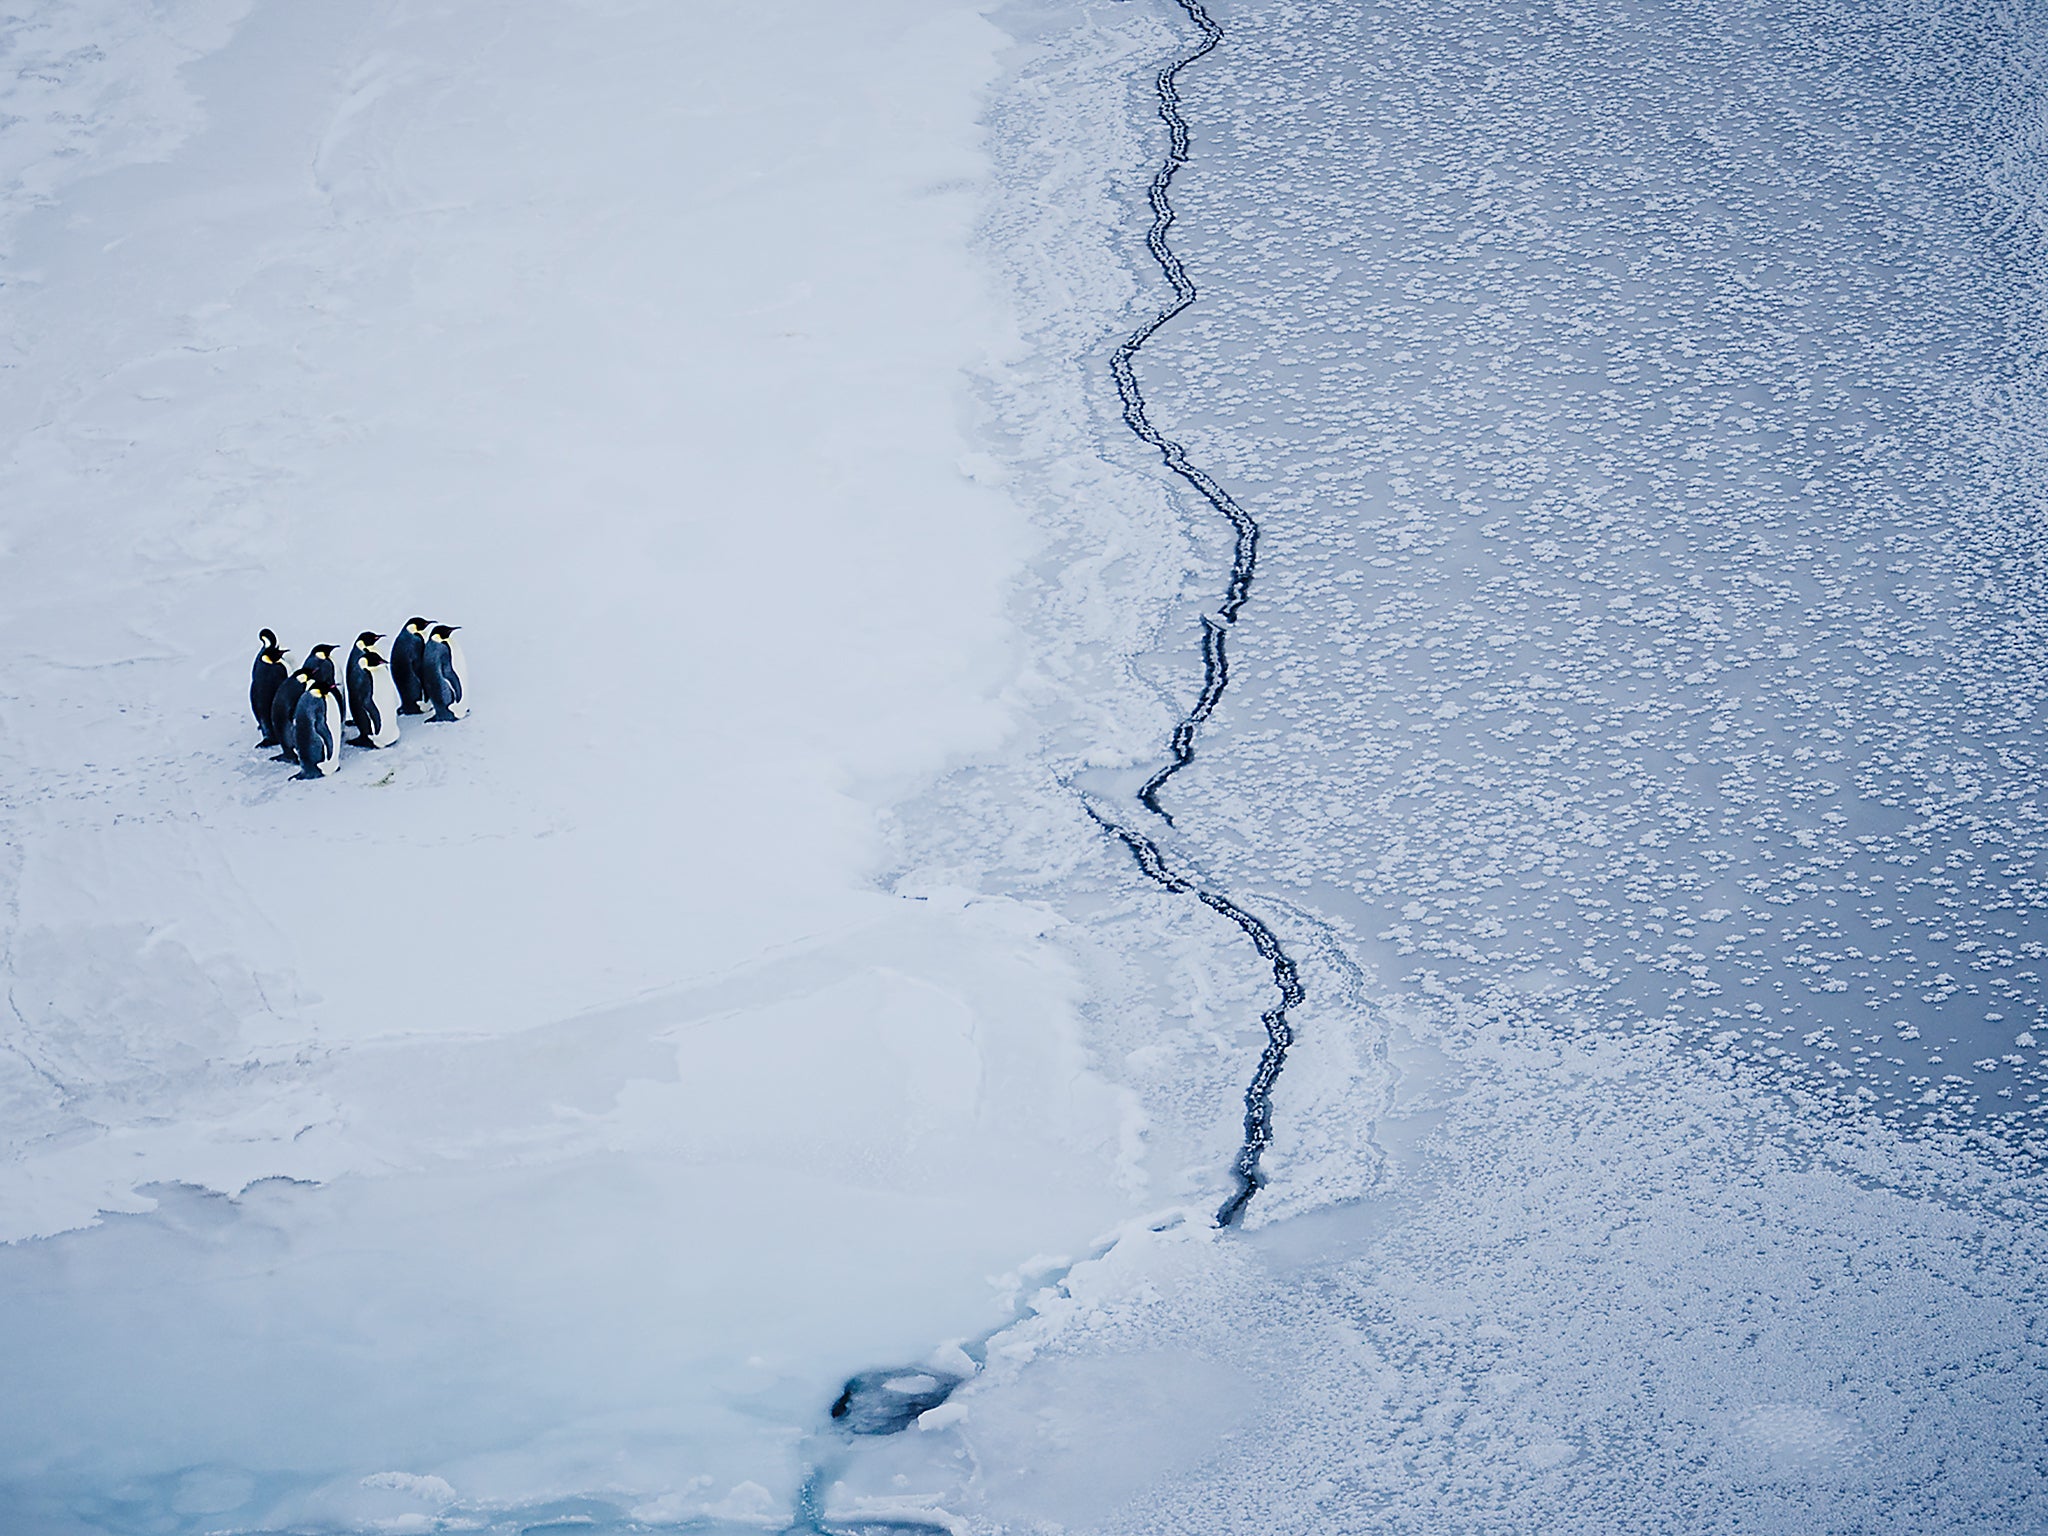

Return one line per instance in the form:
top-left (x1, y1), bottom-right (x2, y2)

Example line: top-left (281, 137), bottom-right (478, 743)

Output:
top-left (0, 0), bottom-right (1139, 1534)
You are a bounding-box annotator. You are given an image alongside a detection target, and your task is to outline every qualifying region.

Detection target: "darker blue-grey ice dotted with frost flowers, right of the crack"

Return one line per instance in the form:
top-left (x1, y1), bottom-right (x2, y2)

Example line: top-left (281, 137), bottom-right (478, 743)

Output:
top-left (1145, 4), bottom-right (2048, 1143)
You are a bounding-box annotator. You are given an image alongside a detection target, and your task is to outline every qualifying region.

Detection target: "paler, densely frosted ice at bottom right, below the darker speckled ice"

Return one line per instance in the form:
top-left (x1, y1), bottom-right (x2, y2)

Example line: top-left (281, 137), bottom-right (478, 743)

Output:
top-left (836, 1020), bottom-right (2048, 1536)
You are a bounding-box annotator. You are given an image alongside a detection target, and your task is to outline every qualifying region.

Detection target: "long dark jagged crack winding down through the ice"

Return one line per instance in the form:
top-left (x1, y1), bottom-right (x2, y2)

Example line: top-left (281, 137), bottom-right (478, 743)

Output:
top-left (1087, 0), bottom-right (1305, 1227)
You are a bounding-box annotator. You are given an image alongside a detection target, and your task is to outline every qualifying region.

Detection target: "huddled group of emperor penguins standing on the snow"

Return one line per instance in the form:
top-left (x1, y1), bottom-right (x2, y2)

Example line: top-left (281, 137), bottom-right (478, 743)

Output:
top-left (250, 618), bottom-right (469, 778)
